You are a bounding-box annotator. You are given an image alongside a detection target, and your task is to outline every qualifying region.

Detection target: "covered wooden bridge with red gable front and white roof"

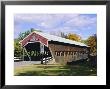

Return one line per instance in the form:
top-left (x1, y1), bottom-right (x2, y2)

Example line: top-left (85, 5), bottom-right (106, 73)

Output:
top-left (20, 31), bottom-right (89, 63)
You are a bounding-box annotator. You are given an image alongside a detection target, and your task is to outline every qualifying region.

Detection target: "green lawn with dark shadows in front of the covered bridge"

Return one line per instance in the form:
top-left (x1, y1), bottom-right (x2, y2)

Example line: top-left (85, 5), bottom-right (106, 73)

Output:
top-left (14, 60), bottom-right (97, 76)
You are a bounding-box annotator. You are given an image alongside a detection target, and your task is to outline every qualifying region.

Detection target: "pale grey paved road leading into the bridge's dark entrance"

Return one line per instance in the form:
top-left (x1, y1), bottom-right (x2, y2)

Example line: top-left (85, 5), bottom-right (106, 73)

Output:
top-left (14, 61), bottom-right (41, 67)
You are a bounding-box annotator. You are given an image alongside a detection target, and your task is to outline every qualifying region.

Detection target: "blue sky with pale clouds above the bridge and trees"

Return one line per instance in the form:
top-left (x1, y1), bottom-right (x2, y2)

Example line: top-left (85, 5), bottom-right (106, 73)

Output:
top-left (14, 13), bottom-right (97, 39)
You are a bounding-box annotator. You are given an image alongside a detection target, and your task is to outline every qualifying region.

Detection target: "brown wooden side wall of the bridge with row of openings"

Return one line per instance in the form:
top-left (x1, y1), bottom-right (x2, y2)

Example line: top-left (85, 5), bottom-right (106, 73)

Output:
top-left (49, 44), bottom-right (88, 63)
